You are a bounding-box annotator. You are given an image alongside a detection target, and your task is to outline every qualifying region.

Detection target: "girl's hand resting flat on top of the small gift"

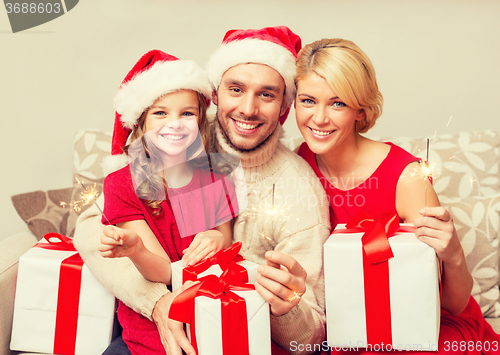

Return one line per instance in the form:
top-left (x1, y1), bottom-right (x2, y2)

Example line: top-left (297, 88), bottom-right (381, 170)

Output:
top-left (182, 230), bottom-right (224, 267)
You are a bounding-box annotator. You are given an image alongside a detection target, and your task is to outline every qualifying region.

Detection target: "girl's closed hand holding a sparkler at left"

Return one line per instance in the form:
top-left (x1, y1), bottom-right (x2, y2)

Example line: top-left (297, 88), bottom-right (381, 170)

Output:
top-left (98, 226), bottom-right (142, 258)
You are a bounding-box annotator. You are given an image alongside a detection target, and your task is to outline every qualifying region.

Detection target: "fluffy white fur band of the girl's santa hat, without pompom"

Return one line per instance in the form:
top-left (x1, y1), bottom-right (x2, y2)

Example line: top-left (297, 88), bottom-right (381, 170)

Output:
top-left (115, 60), bottom-right (212, 129)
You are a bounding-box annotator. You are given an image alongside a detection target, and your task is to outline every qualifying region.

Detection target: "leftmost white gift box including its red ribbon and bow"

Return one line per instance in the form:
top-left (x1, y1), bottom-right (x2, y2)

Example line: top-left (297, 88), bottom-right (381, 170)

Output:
top-left (10, 233), bottom-right (115, 355)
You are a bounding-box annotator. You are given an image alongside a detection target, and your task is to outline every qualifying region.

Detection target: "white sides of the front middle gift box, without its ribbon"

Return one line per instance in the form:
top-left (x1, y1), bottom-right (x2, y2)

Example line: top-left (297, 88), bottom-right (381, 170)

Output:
top-left (188, 290), bottom-right (271, 355)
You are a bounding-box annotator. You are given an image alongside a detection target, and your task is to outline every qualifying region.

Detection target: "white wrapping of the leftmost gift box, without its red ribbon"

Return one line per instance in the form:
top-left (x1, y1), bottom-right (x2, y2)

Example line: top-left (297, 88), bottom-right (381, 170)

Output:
top-left (10, 239), bottom-right (115, 355)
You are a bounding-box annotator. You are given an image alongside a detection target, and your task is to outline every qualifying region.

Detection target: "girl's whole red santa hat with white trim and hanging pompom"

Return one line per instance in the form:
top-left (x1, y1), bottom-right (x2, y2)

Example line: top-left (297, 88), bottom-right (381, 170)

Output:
top-left (102, 50), bottom-right (212, 175)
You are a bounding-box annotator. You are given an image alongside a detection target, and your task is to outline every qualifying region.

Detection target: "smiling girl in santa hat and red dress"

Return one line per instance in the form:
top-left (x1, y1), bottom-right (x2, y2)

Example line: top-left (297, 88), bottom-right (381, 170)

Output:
top-left (99, 50), bottom-right (237, 355)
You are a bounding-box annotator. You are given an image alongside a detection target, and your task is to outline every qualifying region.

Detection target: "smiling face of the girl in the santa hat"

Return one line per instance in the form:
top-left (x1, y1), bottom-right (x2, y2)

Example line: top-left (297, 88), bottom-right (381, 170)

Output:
top-left (144, 90), bottom-right (200, 164)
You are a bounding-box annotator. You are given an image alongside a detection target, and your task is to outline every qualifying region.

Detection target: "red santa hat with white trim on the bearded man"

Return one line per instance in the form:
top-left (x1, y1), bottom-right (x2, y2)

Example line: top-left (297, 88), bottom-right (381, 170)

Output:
top-left (208, 26), bottom-right (302, 124)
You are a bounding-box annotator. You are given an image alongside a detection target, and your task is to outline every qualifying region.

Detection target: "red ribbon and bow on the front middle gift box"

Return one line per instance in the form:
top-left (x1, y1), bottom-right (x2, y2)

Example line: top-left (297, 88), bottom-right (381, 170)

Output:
top-left (168, 270), bottom-right (255, 355)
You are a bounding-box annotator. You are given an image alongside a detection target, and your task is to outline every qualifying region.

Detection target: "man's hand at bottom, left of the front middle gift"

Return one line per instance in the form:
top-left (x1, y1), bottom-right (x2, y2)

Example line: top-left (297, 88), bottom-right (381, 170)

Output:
top-left (153, 281), bottom-right (196, 355)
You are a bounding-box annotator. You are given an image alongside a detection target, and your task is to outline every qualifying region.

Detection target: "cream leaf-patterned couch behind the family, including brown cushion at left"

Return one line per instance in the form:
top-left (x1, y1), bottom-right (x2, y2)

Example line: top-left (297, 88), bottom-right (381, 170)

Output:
top-left (0, 130), bottom-right (500, 355)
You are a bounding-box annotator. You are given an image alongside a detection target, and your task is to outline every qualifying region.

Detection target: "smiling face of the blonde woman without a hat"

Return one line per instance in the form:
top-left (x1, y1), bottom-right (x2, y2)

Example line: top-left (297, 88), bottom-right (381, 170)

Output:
top-left (295, 73), bottom-right (365, 154)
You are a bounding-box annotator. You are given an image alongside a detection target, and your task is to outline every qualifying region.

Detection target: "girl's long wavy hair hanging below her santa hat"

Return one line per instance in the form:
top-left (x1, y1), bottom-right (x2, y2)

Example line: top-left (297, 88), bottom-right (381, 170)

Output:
top-left (123, 91), bottom-right (210, 215)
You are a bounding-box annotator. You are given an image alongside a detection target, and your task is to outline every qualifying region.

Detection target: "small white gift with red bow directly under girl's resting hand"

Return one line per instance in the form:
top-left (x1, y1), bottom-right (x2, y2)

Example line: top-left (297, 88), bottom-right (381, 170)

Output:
top-left (171, 242), bottom-right (259, 291)
